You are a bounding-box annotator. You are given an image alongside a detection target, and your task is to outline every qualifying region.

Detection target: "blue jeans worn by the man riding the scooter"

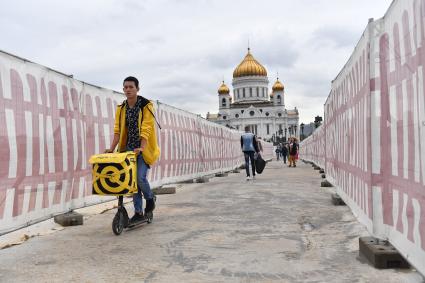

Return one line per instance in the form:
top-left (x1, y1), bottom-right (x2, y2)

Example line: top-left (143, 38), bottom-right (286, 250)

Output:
top-left (129, 150), bottom-right (153, 213)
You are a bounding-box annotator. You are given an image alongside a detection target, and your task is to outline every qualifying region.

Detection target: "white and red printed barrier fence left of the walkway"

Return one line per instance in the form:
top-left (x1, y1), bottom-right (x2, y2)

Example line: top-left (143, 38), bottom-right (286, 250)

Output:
top-left (0, 52), bottom-right (272, 235)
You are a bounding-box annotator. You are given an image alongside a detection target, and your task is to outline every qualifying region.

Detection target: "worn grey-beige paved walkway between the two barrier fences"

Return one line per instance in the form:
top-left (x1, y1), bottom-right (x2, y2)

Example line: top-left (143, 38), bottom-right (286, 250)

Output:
top-left (0, 161), bottom-right (423, 283)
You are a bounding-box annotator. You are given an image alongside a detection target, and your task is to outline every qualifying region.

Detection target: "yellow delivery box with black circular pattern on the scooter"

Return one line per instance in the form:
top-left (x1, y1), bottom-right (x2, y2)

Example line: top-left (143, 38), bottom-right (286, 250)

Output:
top-left (89, 151), bottom-right (137, 196)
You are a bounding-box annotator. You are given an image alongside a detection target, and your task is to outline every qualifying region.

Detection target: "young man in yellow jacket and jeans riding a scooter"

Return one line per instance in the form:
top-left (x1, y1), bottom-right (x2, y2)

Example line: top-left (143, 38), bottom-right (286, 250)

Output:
top-left (105, 77), bottom-right (160, 223)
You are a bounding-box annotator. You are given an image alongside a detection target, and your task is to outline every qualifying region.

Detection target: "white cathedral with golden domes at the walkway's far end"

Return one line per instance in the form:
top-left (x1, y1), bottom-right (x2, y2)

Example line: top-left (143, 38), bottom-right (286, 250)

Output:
top-left (207, 48), bottom-right (299, 142)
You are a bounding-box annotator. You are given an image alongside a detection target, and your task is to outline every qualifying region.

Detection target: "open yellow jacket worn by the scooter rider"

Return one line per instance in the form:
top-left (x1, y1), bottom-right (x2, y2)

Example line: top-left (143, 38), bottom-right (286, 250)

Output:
top-left (114, 100), bottom-right (161, 165)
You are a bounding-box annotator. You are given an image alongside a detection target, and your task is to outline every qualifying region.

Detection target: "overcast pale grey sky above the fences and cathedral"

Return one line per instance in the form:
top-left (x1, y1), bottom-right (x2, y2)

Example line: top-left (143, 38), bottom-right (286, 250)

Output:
top-left (0, 0), bottom-right (391, 123)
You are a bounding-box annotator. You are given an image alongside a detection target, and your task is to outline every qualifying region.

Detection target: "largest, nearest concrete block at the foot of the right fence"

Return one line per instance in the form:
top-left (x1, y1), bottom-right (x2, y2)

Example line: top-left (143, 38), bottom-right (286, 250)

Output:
top-left (359, 237), bottom-right (410, 268)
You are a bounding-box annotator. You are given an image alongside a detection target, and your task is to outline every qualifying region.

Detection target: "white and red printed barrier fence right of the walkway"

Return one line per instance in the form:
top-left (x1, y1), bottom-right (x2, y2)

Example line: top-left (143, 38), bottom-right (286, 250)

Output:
top-left (301, 0), bottom-right (425, 274)
